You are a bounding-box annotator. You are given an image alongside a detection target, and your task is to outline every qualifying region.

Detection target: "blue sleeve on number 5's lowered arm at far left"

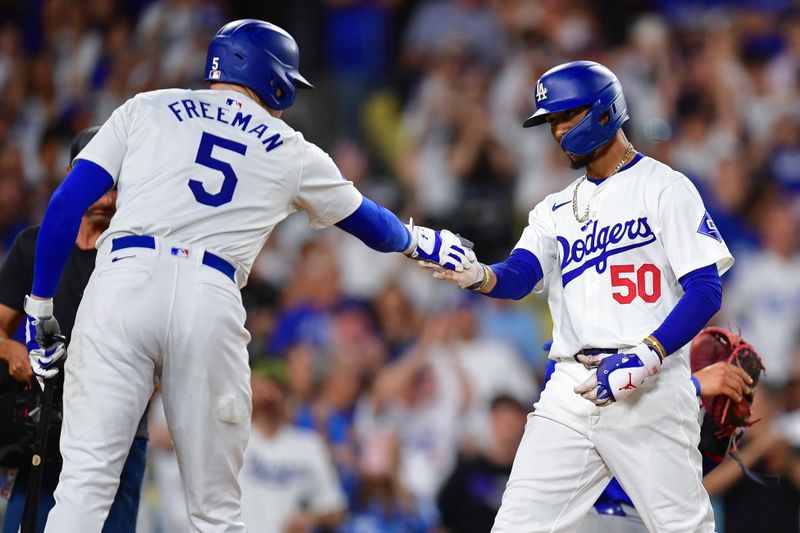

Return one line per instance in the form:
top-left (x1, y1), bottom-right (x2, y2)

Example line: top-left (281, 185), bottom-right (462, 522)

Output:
top-left (31, 159), bottom-right (114, 298)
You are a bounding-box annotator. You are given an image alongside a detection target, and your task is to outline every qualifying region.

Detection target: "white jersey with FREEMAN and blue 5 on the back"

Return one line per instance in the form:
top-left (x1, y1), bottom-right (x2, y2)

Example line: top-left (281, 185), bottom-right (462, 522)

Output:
top-left (78, 89), bottom-right (361, 286)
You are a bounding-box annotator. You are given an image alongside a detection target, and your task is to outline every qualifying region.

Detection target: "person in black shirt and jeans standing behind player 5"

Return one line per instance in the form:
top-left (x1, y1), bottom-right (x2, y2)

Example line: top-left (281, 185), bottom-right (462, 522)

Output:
top-left (0, 127), bottom-right (147, 533)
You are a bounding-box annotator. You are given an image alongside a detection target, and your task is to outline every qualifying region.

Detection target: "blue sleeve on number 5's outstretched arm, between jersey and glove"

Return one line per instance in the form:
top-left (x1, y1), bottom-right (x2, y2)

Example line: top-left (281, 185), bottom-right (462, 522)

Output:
top-left (336, 196), bottom-right (411, 252)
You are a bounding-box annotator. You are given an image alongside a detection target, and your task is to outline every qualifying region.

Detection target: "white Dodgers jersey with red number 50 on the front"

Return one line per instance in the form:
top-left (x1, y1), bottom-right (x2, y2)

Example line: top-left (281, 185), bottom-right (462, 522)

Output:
top-left (516, 156), bottom-right (733, 359)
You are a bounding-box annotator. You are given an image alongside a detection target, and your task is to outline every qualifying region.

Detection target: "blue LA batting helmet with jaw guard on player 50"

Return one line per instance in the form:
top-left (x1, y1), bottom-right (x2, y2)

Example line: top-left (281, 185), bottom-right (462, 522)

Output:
top-left (522, 61), bottom-right (629, 155)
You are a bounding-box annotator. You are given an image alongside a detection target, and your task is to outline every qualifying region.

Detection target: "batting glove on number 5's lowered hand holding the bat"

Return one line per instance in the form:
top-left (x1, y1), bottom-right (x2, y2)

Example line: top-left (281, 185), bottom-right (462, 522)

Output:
top-left (24, 296), bottom-right (67, 388)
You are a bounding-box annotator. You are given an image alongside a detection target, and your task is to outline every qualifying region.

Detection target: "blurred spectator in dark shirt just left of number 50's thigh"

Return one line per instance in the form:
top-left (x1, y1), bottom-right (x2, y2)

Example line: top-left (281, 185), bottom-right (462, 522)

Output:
top-left (438, 395), bottom-right (527, 533)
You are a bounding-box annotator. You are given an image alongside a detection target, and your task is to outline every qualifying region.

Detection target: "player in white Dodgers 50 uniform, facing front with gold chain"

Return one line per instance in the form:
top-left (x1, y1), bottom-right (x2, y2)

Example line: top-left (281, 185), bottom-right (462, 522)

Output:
top-left (434, 61), bottom-right (733, 533)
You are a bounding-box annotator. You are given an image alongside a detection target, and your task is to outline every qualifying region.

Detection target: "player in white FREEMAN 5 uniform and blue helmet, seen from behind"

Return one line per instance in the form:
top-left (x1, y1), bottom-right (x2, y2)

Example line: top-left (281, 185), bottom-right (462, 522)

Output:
top-left (25, 19), bottom-right (471, 533)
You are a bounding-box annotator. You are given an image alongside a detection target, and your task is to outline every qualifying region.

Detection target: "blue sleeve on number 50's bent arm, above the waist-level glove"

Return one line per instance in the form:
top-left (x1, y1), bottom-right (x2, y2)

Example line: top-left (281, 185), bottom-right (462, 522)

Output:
top-left (653, 265), bottom-right (722, 354)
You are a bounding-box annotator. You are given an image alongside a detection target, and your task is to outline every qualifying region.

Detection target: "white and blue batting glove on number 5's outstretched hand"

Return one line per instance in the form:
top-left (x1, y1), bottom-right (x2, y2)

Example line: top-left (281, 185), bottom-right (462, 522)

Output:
top-left (403, 219), bottom-right (475, 272)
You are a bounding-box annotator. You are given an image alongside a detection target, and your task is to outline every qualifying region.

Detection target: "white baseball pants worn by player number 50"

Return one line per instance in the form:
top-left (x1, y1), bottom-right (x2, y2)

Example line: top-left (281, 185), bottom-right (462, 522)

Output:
top-left (492, 353), bottom-right (714, 533)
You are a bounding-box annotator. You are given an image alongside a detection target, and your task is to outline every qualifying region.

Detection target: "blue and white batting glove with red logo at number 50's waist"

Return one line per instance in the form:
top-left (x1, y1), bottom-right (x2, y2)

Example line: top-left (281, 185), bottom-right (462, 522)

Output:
top-left (574, 342), bottom-right (661, 406)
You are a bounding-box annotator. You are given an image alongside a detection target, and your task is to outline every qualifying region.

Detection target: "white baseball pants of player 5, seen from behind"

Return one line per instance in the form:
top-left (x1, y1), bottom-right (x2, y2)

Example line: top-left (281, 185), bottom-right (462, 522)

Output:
top-left (46, 243), bottom-right (252, 533)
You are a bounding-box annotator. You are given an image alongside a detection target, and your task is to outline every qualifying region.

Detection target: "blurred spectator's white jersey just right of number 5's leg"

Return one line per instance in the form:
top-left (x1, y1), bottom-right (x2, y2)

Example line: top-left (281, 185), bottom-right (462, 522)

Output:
top-left (239, 426), bottom-right (347, 532)
